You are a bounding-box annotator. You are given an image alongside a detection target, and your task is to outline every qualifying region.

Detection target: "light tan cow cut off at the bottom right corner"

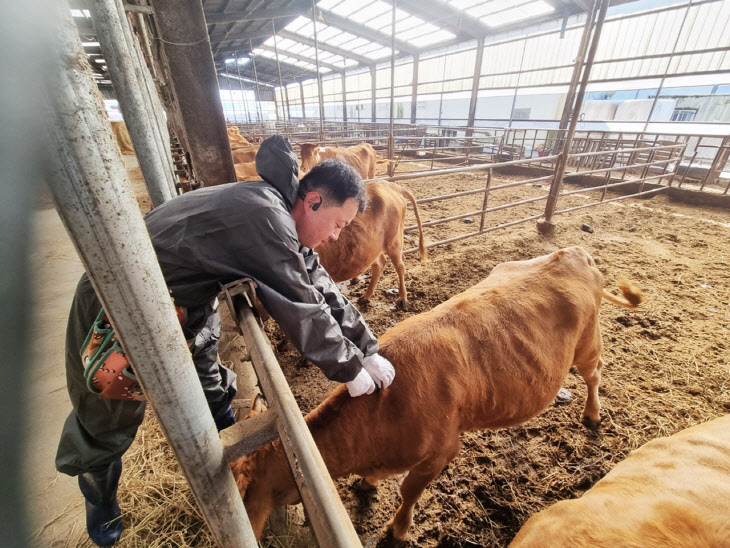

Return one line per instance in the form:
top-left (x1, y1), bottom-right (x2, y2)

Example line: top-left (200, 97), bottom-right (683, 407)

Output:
top-left (510, 415), bottom-right (730, 548)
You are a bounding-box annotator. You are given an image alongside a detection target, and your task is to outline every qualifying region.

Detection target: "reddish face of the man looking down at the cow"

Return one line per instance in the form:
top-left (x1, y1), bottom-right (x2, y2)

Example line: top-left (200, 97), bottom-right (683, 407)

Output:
top-left (297, 192), bottom-right (357, 249)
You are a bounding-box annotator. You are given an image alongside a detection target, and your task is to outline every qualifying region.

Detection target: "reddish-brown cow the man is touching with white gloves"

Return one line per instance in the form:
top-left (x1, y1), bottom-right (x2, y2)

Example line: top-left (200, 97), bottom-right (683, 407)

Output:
top-left (231, 247), bottom-right (641, 539)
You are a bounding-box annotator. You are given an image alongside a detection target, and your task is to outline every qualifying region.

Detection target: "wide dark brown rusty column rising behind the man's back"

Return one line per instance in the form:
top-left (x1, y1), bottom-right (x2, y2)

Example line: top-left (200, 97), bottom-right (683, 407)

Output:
top-left (152, 0), bottom-right (236, 186)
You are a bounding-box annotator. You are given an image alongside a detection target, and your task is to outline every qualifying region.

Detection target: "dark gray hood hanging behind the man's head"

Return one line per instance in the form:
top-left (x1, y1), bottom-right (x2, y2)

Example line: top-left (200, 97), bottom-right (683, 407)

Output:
top-left (256, 135), bottom-right (299, 210)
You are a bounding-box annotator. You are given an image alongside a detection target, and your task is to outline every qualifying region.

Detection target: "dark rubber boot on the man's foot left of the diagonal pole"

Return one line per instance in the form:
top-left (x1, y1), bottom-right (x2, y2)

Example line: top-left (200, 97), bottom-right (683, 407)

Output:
top-left (79, 460), bottom-right (124, 546)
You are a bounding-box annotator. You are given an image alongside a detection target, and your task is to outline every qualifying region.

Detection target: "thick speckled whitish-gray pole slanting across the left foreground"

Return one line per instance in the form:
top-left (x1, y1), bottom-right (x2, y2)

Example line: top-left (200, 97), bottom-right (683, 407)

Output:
top-left (47, 6), bottom-right (257, 547)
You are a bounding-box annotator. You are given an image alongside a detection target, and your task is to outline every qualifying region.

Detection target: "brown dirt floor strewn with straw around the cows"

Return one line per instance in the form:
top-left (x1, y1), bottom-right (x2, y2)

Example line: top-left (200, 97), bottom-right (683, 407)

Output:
top-left (54, 158), bottom-right (730, 547)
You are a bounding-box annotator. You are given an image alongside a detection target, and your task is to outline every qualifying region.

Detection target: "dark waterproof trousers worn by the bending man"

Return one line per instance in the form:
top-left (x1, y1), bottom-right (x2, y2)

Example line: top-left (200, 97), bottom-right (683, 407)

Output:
top-left (56, 274), bottom-right (236, 476)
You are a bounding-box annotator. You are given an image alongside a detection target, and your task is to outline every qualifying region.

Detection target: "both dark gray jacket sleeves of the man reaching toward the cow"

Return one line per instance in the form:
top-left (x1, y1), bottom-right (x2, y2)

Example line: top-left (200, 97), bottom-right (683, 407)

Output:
top-left (249, 204), bottom-right (377, 382)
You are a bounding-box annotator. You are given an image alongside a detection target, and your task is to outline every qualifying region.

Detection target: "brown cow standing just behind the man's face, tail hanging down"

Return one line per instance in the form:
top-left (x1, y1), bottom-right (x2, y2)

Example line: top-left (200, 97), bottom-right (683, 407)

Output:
top-left (317, 181), bottom-right (426, 306)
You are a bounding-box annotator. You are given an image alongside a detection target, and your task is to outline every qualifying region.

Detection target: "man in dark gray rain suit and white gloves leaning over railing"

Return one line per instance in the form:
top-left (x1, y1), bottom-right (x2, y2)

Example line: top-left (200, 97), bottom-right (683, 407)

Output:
top-left (56, 136), bottom-right (395, 546)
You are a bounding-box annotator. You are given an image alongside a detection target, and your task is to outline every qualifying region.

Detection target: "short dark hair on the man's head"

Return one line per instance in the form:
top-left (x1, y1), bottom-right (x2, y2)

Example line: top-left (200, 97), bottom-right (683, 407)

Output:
top-left (299, 158), bottom-right (368, 213)
